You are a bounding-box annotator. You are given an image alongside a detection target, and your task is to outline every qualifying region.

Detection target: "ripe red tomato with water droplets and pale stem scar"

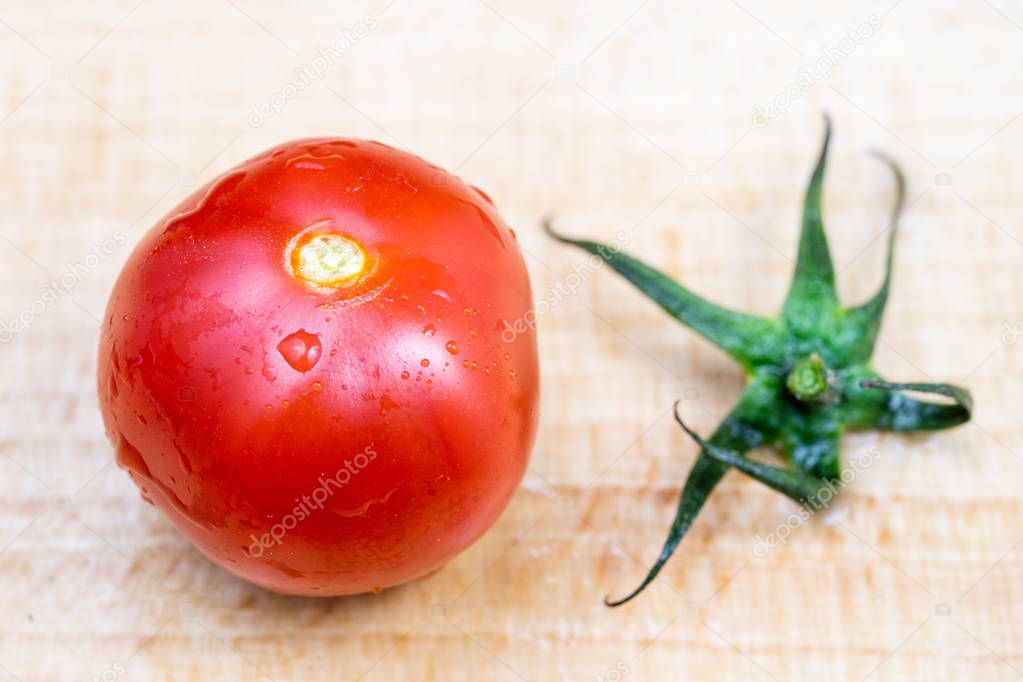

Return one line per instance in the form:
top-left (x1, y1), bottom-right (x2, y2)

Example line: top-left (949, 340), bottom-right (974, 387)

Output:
top-left (98, 139), bottom-right (538, 595)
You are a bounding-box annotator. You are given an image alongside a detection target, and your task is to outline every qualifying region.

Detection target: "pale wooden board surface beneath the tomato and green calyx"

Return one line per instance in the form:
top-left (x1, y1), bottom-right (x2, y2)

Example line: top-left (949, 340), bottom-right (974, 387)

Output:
top-left (0, 0), bottom-right (1023, 682)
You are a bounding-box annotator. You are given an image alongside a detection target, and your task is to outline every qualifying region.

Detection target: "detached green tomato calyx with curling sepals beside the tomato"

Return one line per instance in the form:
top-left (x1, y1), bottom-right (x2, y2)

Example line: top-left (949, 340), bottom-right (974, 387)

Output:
top-left (545, 118), bottom-right (973, 606)
